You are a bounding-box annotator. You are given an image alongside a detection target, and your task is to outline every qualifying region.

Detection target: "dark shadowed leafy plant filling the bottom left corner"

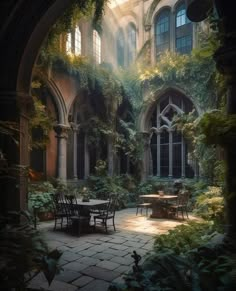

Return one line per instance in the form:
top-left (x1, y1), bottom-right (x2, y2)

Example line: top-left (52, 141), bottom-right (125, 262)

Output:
top-left (0, 212), bottom-right (61, 290)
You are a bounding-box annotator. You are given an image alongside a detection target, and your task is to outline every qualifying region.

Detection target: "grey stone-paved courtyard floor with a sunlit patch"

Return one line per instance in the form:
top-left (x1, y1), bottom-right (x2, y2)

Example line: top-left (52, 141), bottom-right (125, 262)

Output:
top-left (29, 208), bottom-right (194, 291)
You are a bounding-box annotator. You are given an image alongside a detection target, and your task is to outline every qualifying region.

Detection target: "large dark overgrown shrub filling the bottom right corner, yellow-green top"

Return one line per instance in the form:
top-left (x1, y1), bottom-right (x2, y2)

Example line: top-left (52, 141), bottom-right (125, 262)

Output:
top-left (109, 222), bottom-right (236, 291)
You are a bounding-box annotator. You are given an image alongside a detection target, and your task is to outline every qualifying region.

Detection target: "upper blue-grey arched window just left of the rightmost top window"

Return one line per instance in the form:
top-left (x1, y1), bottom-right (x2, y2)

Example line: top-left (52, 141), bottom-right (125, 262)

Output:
top-left (155, 9), bottom-right (170, 56)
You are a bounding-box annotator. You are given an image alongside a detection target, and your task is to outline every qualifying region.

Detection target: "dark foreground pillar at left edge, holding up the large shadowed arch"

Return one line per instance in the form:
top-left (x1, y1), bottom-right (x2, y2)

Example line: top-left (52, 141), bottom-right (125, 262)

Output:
top-left (0, 92), bottom-right (33, 213)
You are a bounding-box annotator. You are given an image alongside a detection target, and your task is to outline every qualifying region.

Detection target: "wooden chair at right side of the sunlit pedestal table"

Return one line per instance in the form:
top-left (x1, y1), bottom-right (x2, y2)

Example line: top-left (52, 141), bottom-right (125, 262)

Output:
top-left (166, 190), bottom-right (190, 219)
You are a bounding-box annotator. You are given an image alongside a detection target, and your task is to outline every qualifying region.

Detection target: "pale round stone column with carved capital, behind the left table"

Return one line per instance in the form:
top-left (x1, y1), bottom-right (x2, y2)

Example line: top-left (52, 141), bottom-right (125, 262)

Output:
top-left (54, 124), bottom-right (70, 180)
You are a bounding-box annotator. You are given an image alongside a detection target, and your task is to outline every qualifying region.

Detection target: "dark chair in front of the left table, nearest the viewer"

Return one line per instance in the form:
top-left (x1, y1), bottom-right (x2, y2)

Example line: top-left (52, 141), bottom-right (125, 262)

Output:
top-left (65, 195), bottom-right (91, 235)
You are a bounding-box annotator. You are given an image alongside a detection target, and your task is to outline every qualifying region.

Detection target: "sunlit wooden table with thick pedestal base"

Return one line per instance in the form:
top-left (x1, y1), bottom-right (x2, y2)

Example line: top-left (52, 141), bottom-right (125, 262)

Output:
top-left (139, 194), bottom-right (178, 218)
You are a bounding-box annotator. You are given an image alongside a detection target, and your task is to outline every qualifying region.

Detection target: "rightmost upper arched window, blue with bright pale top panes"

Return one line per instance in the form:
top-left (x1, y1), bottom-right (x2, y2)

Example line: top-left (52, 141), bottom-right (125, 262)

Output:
top-left (175, 3), bottom-right (193, 54)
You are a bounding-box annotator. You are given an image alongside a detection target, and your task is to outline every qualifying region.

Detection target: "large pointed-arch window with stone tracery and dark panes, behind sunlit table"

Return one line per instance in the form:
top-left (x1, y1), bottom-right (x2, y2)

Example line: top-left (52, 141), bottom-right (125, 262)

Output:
top-left (150, 91), bottom-right (195, 178)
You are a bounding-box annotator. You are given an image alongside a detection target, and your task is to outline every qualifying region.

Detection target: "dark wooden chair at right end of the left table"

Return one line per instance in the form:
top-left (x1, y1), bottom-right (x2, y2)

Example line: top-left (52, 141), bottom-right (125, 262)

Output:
top-left (93, 197), bottom-right (117, 233)
